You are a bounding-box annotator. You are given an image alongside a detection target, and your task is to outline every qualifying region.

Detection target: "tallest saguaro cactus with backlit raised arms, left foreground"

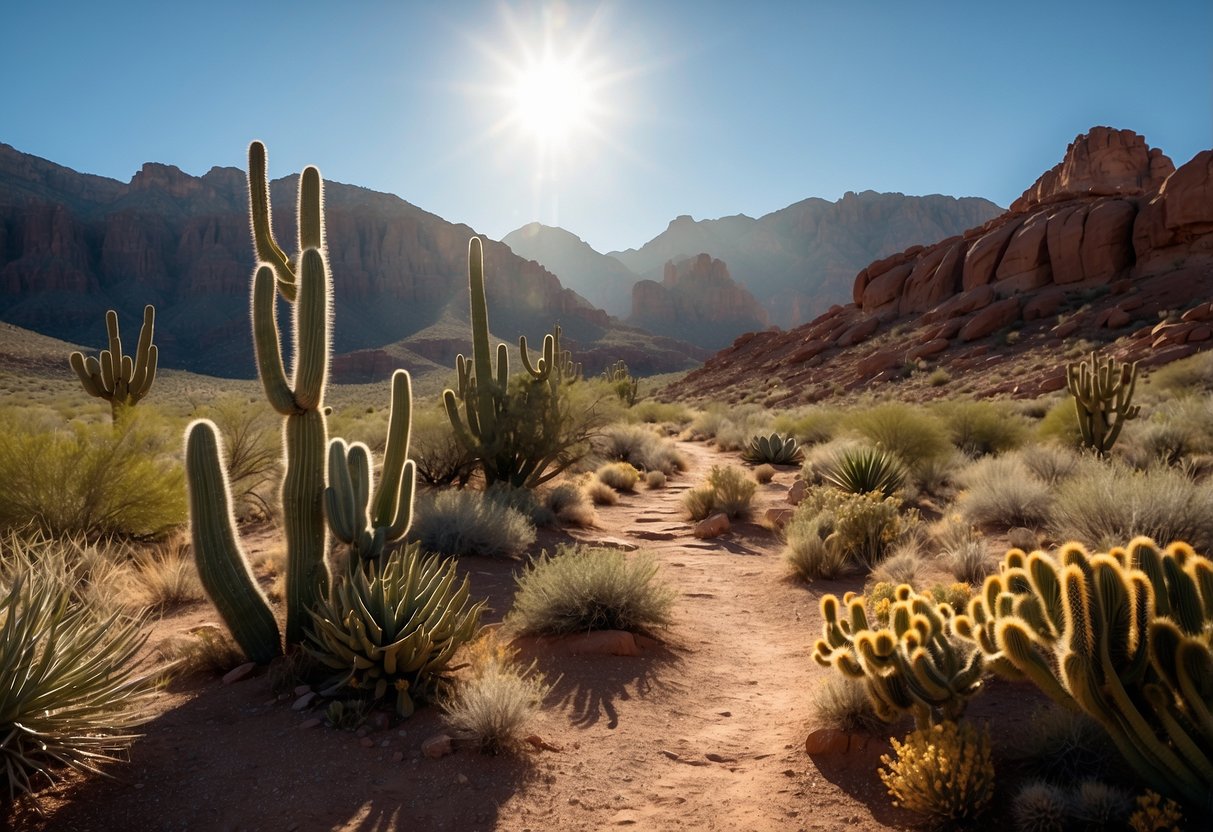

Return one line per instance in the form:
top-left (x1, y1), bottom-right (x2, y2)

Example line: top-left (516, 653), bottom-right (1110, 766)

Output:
top-left (187, 142), bottom-right (331, 657)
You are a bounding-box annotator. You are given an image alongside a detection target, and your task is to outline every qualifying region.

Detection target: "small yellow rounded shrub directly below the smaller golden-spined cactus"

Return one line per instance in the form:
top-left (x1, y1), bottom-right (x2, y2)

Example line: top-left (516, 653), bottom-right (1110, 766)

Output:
top-left (879, 720), bottom-right (993, 821)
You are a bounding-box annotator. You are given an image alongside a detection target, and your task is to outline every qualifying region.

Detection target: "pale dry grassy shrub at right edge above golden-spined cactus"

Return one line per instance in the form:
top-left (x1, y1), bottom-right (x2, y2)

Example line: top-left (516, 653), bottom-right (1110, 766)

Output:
top-left (1049, 461), bottom-right (1213, 552)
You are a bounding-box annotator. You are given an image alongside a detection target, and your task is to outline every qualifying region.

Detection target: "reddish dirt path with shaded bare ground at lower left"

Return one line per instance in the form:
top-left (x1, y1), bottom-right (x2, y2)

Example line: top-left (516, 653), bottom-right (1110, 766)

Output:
top-left (22, 443), bottom-right (900, 832)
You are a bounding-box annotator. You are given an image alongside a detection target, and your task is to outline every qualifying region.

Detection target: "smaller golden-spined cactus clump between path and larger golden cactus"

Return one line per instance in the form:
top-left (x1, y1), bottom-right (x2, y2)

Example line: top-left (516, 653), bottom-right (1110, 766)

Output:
top-left (813, 585), bottom-right (984, 728)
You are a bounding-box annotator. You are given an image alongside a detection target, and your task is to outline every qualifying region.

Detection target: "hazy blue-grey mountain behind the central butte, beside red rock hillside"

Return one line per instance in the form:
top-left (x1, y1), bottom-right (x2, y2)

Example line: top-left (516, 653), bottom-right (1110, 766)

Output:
top-left (610, 190), bottom-right (1002, 326)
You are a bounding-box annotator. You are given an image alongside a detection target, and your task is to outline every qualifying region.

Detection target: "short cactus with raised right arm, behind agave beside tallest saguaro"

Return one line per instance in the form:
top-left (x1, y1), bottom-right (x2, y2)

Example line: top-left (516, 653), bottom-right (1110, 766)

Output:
top-left (324, 370), bottom-right (417, 563)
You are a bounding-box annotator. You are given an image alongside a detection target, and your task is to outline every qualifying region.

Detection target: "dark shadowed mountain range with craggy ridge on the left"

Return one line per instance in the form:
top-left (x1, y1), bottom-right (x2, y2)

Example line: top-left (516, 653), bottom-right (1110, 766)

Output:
top-left (0, 144), bottom-right (705, 381)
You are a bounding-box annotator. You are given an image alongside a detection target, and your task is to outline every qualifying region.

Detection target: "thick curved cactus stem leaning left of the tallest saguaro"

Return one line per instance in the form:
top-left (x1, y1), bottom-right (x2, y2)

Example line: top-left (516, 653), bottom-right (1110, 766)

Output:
top-left (186, 420), bottom-right (281, 663)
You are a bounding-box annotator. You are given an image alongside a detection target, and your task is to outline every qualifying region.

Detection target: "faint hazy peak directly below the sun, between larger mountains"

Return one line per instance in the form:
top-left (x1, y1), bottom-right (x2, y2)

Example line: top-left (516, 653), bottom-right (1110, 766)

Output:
top-left (501, 222), bottom-right (640, 318)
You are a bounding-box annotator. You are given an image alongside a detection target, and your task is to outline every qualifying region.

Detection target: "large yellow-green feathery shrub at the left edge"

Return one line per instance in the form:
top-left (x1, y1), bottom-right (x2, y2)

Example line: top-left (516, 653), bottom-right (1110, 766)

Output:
top-left (0, 405), bottom-right (186, 537)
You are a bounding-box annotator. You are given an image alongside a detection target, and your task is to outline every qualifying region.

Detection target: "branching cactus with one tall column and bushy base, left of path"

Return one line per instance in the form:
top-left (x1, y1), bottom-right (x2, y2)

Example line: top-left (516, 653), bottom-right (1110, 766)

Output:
top-left (443, 237), bottom-right (575, 488)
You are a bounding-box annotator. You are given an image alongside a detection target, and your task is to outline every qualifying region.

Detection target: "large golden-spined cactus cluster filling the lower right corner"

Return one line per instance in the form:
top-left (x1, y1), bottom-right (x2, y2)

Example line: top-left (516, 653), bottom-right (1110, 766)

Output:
top-left (952, 537), bottom-right (1213, 805)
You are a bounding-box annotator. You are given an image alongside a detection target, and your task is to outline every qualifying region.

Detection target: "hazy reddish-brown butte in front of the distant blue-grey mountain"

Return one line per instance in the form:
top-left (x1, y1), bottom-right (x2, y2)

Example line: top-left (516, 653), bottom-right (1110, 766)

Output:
top-left (628, 253), bottom-right (767, 349)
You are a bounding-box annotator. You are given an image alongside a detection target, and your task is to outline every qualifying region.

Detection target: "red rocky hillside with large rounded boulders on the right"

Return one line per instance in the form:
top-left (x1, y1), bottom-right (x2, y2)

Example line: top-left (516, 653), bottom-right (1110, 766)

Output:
top-left (665, 127), bottom-right (1213, 404)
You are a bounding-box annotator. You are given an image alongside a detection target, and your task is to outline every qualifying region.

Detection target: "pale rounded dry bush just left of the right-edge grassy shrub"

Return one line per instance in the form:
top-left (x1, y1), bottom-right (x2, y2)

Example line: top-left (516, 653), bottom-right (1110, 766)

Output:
top-left (958, 456), bottom-right (1052, 528)
